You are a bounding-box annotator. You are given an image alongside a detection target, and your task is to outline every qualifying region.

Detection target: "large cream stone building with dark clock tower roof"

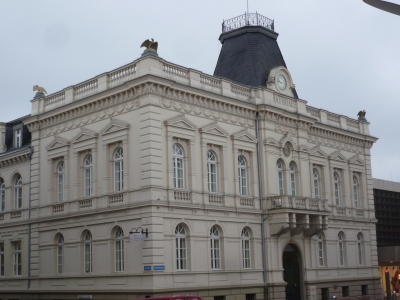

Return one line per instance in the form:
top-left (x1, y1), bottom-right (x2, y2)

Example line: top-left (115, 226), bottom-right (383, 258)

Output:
top-left (0, 14), bottom-right (381, 300)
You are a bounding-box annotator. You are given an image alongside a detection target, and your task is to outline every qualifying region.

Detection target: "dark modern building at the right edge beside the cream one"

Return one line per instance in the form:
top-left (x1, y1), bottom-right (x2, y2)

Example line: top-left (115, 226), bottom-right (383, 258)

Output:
top-left (373, 178), bottom-right (400, 293)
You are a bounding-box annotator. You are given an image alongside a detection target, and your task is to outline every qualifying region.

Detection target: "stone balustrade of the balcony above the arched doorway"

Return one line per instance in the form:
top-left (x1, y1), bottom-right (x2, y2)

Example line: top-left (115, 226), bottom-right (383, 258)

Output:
top-left (264, 195), bottom-right (329, 212)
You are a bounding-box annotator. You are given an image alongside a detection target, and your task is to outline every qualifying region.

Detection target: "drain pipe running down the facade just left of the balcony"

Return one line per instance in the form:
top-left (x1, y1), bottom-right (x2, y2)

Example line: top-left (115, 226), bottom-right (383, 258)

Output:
top-left (255, 112), bottom-right (268, 299)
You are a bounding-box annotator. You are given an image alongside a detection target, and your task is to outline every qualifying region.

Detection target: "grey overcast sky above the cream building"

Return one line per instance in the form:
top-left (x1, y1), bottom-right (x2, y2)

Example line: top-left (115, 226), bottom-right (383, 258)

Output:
top-left (0, 0), bottom-right (400, 181)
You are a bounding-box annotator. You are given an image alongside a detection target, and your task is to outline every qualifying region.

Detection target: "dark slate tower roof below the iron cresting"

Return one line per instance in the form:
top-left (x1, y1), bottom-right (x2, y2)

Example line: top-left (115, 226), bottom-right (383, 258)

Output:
top-left (214, 26), bottom-right (297, 98)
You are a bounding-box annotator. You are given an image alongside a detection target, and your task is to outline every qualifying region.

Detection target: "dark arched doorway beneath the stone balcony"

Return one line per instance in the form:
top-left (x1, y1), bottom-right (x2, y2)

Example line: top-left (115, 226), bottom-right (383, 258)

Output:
top-left (282, 244), bottom-right (302, 300)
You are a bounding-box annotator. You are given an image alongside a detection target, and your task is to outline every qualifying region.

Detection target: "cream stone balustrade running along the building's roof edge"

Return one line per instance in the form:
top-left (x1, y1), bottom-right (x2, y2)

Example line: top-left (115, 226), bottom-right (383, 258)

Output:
top-left (31, 53), bottom-right (368, 133)
